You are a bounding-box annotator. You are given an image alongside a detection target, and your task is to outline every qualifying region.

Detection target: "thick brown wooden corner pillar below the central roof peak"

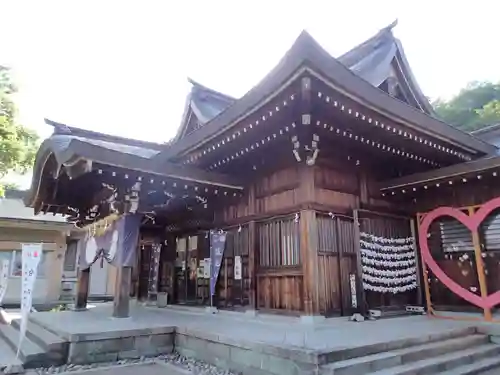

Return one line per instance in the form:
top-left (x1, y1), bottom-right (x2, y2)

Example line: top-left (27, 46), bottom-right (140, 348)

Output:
top-left (299, 210), bottom-right (319, 315)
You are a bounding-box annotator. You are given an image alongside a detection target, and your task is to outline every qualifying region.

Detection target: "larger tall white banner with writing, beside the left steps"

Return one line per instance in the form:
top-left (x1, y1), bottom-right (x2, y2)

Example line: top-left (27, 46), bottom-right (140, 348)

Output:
top-left (17, 243), bottom-right (43, 358)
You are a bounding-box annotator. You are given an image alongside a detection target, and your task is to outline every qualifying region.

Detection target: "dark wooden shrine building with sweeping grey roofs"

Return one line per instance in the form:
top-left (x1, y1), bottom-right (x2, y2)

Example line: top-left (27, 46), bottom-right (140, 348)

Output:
top-left (26, 24), bottom-right (500, 324)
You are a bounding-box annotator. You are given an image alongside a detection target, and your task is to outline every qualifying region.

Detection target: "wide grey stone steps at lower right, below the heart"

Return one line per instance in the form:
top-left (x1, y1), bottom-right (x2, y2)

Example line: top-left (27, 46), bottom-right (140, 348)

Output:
top-left (321, 334), bottom-right (500, 375)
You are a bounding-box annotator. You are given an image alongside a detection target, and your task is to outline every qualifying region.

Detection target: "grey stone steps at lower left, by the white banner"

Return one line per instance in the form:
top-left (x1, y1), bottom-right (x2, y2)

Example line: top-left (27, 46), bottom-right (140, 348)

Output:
top-left (0, 322), bottom-right (68, 368)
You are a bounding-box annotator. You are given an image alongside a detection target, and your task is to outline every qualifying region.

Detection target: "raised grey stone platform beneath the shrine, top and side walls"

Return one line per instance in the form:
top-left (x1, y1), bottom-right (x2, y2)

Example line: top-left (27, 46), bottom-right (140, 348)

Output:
top-left (22, 305), bottom-right (500, 375)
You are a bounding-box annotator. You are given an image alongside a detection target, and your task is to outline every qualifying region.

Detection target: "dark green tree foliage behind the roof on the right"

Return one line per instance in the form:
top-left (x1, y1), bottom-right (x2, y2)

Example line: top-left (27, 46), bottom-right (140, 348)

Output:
top-left (433, 82), bottom-right (500, 131)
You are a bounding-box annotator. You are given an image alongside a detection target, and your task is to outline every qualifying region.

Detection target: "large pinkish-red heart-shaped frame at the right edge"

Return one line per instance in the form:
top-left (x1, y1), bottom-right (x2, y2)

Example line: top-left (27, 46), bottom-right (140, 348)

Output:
top-left (418, 198), bottom-right (500, 309)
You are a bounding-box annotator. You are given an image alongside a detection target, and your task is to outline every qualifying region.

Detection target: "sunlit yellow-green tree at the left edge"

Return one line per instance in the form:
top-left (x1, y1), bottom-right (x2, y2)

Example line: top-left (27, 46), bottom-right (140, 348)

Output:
top-left (0, 65), bottom-right (38, 196)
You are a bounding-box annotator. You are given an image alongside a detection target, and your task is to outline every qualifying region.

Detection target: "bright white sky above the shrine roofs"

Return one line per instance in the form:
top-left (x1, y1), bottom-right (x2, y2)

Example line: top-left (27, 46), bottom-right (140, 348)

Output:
top-left (0, 0), bottom-right (500, 187)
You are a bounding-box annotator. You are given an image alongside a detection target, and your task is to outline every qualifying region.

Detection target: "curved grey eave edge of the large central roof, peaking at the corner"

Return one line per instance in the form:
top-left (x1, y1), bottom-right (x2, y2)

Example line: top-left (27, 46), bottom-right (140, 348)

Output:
top-left (153, 31), bottom-right (496, 163)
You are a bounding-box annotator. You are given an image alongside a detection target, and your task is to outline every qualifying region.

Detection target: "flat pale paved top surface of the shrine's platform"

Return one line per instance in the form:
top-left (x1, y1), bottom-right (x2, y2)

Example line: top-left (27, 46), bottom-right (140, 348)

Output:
top-left (32, 304), bottom-right (473, 350)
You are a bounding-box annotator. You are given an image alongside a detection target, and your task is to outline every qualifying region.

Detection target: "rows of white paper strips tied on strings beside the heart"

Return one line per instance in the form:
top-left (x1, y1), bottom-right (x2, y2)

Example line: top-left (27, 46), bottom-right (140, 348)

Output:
top-left (360, 232), bottom-right (417, 294)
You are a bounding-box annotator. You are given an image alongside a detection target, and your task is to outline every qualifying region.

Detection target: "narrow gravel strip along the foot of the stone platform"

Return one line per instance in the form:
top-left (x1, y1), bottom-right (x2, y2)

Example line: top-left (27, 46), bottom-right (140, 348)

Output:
top-left (21, 353), bottom-right (240, 375)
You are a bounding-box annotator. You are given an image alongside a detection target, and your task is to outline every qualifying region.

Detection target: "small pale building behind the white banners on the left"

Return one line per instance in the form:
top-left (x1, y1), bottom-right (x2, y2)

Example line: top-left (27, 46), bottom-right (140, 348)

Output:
top-left (0, 190), bottom-right (114, 306)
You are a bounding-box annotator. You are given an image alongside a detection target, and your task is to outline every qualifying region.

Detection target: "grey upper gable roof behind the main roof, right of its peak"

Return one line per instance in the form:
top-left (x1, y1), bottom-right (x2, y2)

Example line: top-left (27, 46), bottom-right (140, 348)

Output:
top-left (338, 21), bottom-right (434, 114)
